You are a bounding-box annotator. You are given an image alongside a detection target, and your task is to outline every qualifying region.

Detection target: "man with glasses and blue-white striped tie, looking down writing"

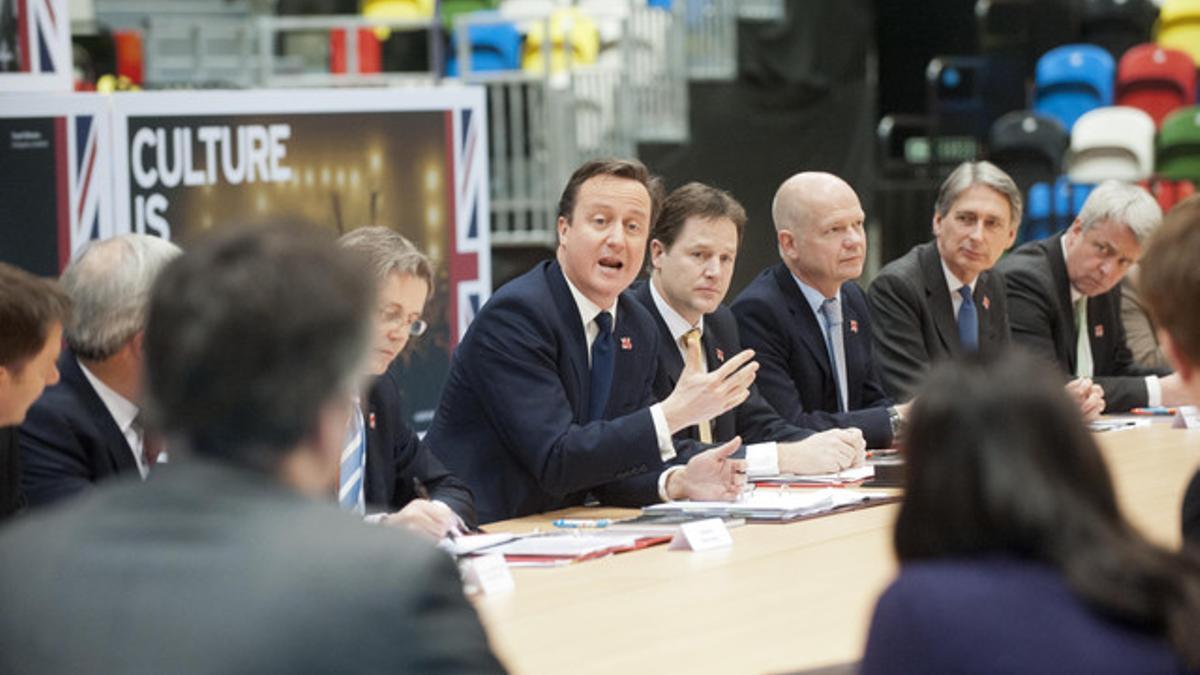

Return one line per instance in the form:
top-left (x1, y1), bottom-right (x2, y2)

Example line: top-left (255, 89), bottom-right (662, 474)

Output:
top-left (337, 227), bottom-right (475, 538)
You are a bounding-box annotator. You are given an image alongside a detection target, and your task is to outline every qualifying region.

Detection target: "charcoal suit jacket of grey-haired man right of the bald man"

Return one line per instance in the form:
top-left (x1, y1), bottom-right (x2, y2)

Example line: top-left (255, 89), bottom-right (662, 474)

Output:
top-left (866, 241), bottom-right (1012, 400)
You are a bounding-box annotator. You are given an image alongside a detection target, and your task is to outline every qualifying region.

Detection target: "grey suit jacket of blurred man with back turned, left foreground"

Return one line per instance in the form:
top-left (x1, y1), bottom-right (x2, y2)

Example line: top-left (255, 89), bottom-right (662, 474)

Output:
top-left (0, 458), bottom-right (503, 675)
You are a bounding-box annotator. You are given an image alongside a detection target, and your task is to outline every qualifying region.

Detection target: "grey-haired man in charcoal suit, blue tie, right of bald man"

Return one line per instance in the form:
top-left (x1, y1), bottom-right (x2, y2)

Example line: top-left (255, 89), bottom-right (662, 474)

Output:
top-left (868, 162), bottom-right (1104, 417)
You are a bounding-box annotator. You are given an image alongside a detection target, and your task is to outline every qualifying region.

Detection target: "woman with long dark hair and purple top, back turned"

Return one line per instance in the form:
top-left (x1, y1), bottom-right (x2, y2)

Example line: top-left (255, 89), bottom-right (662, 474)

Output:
top-left (862, 356), bottom-right (1200, 675)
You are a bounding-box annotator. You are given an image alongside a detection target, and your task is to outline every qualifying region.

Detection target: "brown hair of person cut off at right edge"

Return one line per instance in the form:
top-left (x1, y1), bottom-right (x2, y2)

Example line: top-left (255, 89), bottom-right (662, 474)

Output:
top-left (1138, 195), bottom-right (1200, 365)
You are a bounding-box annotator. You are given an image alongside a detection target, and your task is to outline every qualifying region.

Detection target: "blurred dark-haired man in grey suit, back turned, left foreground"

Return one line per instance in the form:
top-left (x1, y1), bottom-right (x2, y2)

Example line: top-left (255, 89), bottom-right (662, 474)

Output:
top-left (0, 226), bottom-right (502, 674)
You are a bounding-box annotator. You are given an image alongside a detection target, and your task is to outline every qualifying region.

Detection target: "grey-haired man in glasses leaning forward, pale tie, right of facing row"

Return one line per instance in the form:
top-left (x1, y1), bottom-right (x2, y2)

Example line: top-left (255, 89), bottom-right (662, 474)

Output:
top-left (998, 181), bottom-right (1184, 412)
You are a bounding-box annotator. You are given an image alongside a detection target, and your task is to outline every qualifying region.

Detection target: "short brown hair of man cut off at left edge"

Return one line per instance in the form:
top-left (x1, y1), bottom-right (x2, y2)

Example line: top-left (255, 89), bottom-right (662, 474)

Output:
top-left (0, 263), bottom-right (71, 372)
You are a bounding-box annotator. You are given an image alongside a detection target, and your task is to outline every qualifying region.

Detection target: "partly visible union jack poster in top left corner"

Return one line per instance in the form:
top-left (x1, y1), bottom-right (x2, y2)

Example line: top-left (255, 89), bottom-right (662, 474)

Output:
top-left (0, 0), bottom-right (74, 95)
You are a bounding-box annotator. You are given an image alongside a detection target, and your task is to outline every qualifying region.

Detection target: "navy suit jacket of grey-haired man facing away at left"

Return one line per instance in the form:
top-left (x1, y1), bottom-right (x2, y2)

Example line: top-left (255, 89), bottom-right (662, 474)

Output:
top-left (20, 350), bottom-right (140, 506)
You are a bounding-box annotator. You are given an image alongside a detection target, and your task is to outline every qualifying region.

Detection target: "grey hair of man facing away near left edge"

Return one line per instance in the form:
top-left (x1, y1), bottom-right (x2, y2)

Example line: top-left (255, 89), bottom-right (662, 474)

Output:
top-left (62, 234), bottom-right (180, 360)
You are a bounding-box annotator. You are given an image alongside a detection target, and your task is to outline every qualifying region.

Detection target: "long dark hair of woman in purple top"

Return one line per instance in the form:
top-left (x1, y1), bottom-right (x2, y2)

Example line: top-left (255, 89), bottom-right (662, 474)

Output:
top-left (895, 353), bottom-right (1200, 668)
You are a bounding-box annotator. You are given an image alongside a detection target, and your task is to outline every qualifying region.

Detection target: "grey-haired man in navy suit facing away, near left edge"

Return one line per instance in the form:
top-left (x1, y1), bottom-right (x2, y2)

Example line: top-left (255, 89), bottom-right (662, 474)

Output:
top-left (20, 234), bottom-right (179, 507)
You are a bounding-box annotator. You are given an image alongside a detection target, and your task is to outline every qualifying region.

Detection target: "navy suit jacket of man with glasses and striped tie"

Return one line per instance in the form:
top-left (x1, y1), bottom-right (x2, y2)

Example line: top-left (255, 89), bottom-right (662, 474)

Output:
top-left (362, 374), bottom-right (476, 527)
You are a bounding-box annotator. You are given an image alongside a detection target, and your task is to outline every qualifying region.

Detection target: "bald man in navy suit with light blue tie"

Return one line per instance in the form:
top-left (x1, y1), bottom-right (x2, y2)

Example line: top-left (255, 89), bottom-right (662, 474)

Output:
top-left (731, 172), bottom-right (902, 448)
